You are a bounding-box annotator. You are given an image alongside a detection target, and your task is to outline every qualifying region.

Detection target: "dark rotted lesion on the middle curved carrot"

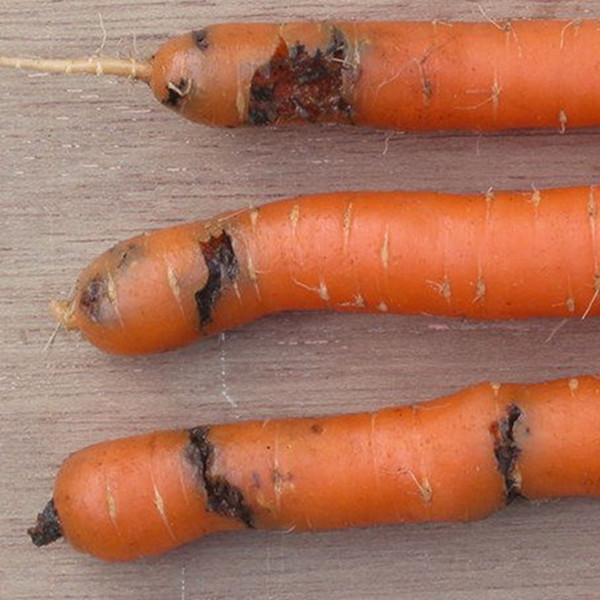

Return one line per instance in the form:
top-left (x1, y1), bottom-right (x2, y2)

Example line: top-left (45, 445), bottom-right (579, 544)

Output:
top-left (194, 231), bottom-right (239, 327)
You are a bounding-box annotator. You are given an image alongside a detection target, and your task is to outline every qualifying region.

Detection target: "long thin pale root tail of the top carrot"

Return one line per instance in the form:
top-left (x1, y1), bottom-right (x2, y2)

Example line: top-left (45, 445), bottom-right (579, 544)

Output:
top-left (0, 56), bottom-right (152, 82)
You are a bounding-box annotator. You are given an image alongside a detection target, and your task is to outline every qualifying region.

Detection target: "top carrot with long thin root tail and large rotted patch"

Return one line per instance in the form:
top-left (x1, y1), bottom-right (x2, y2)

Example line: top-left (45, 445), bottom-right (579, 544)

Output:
top-left (0, 20), bottom-right (600, 131)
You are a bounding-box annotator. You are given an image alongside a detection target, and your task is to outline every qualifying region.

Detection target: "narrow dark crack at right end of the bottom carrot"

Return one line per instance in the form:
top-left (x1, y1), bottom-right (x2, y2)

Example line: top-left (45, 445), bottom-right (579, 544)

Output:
top-left (491, 404), bottom-right (523, 504)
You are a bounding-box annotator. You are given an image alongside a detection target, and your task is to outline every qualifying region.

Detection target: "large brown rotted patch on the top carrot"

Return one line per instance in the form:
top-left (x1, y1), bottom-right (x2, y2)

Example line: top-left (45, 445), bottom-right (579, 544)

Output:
top-left (248, 27), bottom-right (352, 125)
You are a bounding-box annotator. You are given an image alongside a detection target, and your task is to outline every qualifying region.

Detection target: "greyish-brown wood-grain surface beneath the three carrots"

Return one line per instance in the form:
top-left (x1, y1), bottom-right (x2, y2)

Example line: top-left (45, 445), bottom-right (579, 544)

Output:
top-left (0, 0), bottom-right (600, 599)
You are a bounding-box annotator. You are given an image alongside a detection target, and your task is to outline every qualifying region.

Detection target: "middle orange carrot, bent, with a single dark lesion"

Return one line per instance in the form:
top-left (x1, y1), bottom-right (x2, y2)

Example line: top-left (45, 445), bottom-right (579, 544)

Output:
top-left (54, 186), bottom-right (600, 354)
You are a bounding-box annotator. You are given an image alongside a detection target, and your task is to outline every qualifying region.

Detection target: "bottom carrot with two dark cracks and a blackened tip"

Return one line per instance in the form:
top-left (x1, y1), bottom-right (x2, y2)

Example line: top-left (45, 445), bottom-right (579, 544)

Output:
top-left (29, 377), bottom-right (600, 560)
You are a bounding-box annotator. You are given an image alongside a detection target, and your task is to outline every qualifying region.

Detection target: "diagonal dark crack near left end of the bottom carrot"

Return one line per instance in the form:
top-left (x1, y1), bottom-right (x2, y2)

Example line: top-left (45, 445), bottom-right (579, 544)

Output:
top-left (186, 427), bottom-right (254, 528)
